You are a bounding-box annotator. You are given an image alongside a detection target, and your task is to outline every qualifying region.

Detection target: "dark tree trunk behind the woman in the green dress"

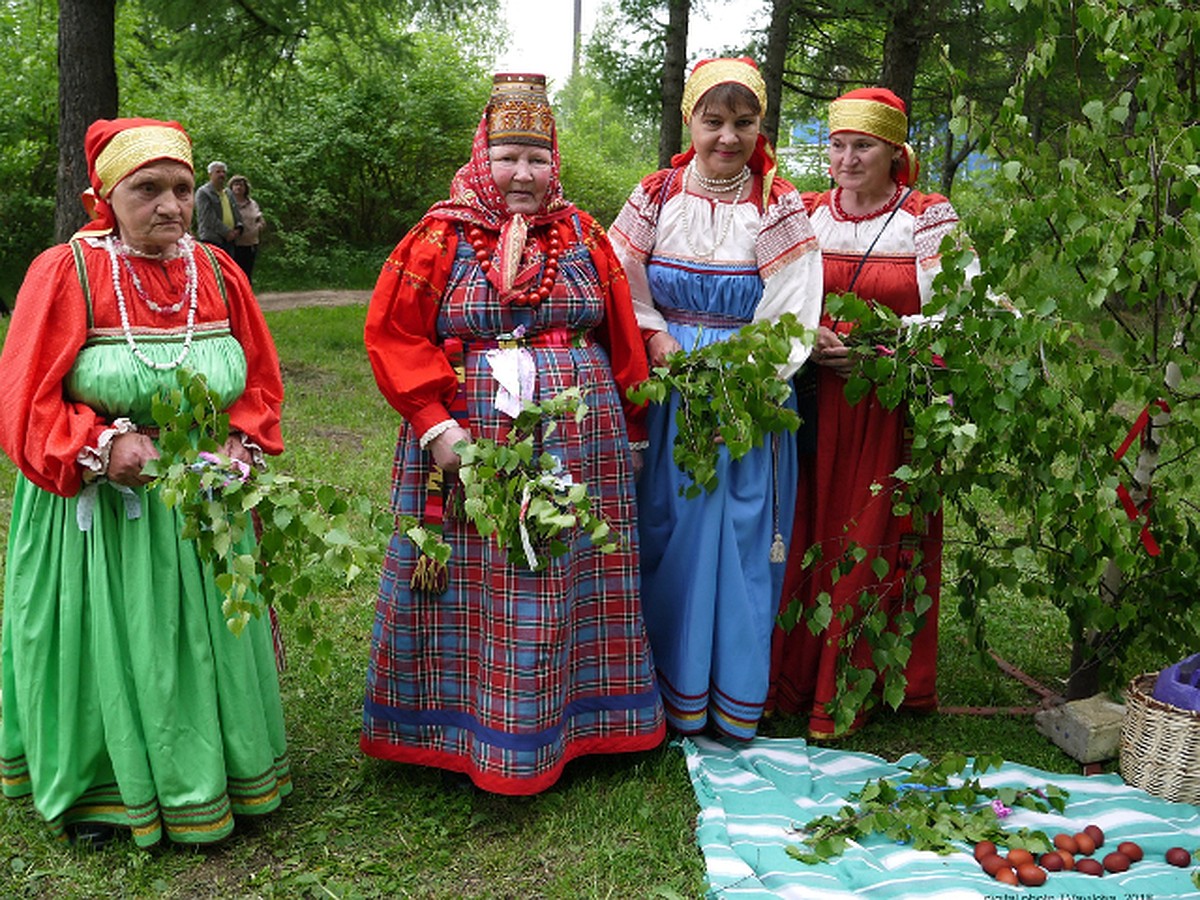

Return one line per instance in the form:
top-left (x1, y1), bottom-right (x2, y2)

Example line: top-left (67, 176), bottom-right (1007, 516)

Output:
top-left (54, 0), bottom-right (116, 241)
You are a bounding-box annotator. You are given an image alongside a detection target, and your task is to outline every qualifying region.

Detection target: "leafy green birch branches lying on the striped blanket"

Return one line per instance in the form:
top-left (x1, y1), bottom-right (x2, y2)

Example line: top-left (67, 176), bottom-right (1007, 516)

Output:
top-left (787, 754), bottom-right (1069, 864)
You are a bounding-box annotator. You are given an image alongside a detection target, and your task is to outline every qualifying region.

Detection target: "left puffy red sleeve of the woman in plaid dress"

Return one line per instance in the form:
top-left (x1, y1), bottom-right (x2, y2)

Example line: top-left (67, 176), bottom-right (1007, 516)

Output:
top-left (362, 218), bottom-right (458, 434)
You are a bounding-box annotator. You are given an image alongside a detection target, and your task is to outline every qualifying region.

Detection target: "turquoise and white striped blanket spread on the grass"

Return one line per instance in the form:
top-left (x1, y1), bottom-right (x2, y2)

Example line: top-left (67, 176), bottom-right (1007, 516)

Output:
top-left (682, 738), bottom-right (1200, 900)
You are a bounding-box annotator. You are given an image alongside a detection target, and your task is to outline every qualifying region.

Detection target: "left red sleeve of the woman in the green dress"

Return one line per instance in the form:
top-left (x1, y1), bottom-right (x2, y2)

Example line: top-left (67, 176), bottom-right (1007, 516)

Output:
top-left (0, 244), bottom-right (108, 497)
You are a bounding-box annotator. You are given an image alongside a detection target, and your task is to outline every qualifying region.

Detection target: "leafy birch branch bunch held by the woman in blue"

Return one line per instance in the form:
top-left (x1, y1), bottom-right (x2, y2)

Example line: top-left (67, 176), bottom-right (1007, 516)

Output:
top-left (629, 313), bottom-right (815, 497)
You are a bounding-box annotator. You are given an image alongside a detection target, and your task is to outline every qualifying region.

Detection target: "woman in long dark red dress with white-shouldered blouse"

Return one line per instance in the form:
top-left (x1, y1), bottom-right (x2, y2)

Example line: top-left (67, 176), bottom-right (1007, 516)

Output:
top-left (768, 88), bottom-right (978, 738)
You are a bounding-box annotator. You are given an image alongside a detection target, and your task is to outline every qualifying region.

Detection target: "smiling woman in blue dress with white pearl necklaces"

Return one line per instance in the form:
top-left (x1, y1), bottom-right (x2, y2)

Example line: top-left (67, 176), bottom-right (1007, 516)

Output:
top-left (610, 58), bottom-right (822, 739)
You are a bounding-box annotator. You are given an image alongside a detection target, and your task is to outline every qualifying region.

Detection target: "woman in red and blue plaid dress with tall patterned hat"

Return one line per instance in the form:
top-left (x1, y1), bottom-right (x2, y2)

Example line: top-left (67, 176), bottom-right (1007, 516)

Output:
top-left (361, 76), bottom-right (665, 794)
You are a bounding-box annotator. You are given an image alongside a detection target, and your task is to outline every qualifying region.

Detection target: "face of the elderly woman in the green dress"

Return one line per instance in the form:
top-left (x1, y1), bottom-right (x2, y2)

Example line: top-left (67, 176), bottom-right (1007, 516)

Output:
top-left (108, 160), bottom-right (196, 253)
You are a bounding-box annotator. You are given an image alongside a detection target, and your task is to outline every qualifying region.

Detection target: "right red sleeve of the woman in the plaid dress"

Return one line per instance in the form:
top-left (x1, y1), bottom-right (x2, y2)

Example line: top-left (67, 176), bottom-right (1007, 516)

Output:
top-left (580, 212), bottom-right (650, 442)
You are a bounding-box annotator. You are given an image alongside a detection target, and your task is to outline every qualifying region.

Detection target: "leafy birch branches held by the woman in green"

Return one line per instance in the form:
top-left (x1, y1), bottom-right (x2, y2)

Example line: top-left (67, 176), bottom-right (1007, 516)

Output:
top-left (146, 368), bottom-right (392, 670)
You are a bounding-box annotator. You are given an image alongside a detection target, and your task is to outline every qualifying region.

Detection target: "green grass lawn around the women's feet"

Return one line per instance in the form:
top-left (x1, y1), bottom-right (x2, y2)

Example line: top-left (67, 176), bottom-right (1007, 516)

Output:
top-left (0, 307), bottom-right (1165, 899)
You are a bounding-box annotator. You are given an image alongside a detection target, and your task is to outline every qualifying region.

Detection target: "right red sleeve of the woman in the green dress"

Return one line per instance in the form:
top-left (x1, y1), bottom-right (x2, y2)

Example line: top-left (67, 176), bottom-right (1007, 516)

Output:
top-left (214, 248), bottom-right (283, 454)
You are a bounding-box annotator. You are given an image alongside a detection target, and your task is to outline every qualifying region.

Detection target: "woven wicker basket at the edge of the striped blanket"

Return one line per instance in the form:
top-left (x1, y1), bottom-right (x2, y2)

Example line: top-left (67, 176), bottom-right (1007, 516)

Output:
top-left (1121, 672), bottom-right (1200, 804)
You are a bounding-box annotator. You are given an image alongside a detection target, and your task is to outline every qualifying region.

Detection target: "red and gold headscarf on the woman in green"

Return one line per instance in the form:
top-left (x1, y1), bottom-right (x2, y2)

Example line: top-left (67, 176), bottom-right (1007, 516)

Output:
top-left (80, 119), bottom-right (193, 234)
